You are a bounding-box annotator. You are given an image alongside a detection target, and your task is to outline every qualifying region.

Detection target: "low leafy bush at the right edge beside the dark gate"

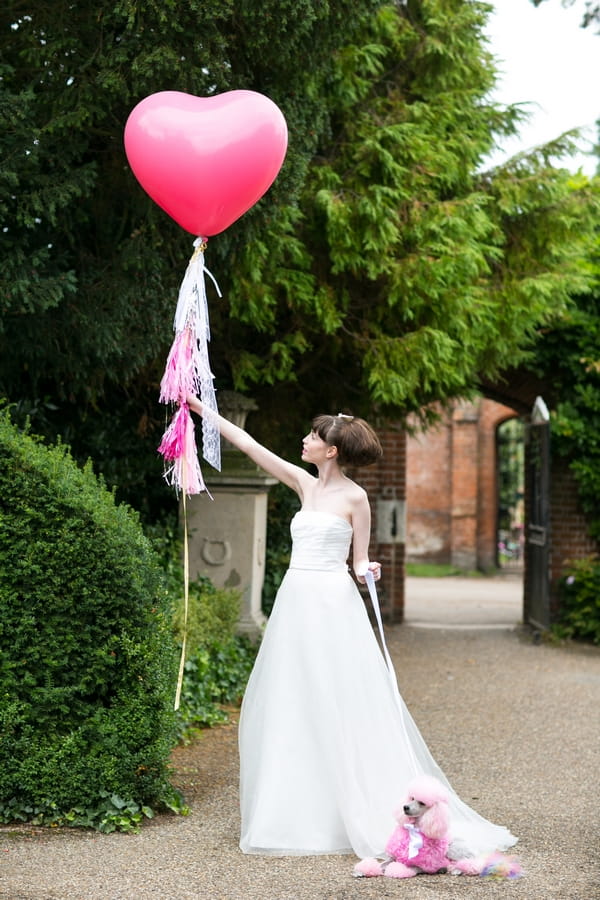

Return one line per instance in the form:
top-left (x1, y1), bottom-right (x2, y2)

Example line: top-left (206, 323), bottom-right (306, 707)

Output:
top-left (553, 556), bottom-right (600, 644)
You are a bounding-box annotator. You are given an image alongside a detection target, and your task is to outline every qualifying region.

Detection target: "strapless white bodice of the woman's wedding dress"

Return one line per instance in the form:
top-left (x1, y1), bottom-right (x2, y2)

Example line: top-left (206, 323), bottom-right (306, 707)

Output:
top-left (290, 509), bottom-right (352, 571)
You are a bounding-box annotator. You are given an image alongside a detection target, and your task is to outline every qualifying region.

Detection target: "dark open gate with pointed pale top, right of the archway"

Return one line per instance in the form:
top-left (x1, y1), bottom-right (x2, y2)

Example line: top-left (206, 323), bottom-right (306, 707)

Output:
top-left (525, 397), bottom-right (550, 631)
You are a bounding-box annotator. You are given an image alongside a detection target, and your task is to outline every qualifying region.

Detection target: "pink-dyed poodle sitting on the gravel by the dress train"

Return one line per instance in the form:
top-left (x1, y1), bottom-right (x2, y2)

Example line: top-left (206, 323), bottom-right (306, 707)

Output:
top-left (354, 775), bottom-right (521, 878)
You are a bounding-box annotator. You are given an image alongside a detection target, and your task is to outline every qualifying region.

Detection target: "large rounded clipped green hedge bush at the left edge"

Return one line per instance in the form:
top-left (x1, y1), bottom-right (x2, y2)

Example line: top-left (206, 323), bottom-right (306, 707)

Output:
top-left (0, 410), bottom-right (178, 830)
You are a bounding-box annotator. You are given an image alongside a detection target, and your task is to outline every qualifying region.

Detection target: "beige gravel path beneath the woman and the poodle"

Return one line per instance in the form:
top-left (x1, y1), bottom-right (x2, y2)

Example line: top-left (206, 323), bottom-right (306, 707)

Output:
top-left (0, 582), bottom-right (600, 900)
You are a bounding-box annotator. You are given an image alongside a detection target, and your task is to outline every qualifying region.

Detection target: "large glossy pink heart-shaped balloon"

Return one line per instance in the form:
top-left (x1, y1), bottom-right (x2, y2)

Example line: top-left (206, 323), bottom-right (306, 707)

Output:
top-left (125, 91), bottom-right (287, 237)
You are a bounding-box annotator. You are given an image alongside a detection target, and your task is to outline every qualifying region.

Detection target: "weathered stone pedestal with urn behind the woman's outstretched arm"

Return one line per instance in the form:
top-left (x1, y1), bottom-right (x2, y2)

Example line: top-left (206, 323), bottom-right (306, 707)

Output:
top-left (188, 391), bottom-right (276, 639)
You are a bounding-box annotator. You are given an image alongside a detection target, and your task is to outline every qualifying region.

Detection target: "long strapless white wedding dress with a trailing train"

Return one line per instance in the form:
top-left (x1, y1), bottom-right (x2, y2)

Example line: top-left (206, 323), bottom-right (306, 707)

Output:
top-left (239, 510), bottom-right (516, 857)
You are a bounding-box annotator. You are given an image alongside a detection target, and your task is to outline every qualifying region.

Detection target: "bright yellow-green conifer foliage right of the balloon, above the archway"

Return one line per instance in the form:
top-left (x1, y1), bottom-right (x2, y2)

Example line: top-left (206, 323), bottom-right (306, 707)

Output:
top-left (231, 2), bottom-right (596, 428)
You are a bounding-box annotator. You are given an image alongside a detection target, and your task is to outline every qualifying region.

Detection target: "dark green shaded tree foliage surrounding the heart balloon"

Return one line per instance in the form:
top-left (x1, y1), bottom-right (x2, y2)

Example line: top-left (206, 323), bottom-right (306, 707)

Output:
top-left (0, 0), bottom-right (378, 501)
